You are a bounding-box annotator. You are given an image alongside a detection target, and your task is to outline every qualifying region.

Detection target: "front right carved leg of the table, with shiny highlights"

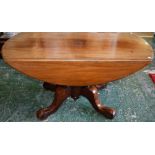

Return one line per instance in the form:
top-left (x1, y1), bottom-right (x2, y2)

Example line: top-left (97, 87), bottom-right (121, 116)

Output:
top-left (81, 86), bottom-right (116, 119)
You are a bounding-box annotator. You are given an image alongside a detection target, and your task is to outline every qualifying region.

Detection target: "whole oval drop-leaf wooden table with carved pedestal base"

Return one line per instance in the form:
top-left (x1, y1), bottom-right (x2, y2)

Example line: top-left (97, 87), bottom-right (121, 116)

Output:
top-left (2, 32), bottom-right (153, 119)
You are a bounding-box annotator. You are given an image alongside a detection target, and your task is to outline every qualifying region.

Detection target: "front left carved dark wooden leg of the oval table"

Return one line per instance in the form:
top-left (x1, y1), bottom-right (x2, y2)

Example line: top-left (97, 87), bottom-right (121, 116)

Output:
top-left (37, 86), bottom-right (70, 120)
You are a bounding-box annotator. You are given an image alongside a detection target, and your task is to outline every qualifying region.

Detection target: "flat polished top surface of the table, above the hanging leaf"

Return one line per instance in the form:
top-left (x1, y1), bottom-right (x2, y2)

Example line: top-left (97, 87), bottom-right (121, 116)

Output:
top-left (4, 33), bottom-right (152, 61)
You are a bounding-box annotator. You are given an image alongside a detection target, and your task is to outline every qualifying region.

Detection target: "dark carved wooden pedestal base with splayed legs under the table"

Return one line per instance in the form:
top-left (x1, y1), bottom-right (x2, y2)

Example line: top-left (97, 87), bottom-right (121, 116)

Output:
top-left (37, 82), bottom-right (116, 120)
